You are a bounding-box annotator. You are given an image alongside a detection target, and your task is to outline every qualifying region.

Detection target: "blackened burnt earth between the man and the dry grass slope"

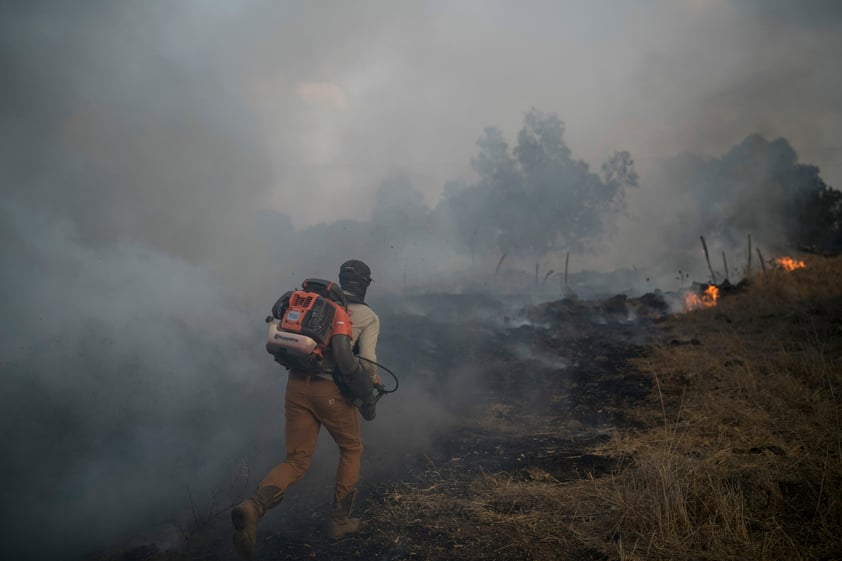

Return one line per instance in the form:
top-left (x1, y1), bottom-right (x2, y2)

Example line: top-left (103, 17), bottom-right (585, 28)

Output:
top-left (103, 294), bottom-right (668, 561)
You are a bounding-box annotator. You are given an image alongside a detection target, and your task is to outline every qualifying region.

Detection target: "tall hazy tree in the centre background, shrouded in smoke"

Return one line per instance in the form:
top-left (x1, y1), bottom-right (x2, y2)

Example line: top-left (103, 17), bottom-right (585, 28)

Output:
top-left (442, 108), bottom-right (637, 256)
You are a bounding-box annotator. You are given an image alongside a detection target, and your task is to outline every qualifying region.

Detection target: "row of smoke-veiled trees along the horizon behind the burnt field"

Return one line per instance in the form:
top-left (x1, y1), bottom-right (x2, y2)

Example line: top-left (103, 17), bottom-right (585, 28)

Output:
top-left (272, 118), bottom-right (842, 299)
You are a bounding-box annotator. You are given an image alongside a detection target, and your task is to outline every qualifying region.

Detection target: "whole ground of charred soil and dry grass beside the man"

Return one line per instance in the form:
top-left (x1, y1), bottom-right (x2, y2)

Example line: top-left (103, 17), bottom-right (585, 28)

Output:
top-left (92, 259), bottom-right (842, 561)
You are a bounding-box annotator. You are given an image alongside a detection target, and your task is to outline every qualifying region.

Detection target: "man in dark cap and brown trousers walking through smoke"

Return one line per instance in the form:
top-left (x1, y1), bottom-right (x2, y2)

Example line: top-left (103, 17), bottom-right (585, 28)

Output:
top-left (231, 259), bottom-right (380, 559)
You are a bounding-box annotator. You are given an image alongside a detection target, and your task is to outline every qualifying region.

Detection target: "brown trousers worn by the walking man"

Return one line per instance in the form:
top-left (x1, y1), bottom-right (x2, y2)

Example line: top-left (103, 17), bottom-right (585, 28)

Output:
top-left (260, 372), bottom-right (363, 500)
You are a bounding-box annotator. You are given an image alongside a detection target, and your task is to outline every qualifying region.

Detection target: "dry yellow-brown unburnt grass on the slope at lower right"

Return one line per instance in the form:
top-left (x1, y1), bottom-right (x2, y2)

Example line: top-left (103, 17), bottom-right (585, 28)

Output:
top-left (374, 258), bottom-right (842, 561)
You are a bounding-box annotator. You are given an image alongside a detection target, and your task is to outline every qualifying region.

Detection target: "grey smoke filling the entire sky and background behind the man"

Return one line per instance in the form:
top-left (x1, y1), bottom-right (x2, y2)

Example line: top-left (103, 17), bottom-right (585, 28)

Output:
top-left (0, 0), bottom-right (842, 559)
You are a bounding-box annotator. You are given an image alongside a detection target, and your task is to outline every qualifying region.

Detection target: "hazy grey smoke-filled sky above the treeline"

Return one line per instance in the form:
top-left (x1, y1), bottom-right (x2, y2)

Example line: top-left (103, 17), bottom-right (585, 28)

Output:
top-left (0, 0), bottom-right (842, 235)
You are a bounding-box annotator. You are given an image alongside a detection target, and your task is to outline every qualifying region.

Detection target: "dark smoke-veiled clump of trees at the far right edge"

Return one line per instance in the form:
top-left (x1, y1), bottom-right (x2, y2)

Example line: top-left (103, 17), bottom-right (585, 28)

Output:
top-left (601, 134), bottom-right (842, 288)
